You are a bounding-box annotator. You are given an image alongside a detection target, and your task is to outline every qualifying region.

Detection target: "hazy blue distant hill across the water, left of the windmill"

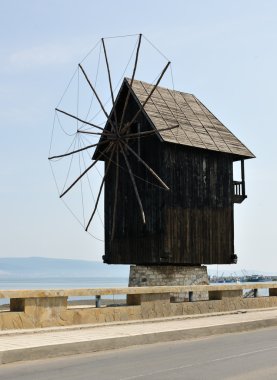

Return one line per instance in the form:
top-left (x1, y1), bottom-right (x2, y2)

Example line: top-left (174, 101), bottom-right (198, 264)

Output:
top-left (0, 257), bottom-right (129, 278)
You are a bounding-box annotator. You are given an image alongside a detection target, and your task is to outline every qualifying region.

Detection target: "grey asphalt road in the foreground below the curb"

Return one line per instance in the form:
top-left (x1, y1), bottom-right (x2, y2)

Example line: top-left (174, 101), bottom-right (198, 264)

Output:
top-left (0, 328), bottom-right (277, 380)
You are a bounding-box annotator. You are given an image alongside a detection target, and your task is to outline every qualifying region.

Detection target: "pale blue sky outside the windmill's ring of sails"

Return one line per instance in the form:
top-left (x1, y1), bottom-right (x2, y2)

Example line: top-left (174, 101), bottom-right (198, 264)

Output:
top-left (0, 0), bottom-right (277, 272)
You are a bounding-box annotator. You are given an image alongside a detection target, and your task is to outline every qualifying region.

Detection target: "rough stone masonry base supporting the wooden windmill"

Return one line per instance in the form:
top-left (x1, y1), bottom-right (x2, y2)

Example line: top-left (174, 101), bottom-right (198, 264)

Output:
top-left (129, 265), bottom-right (209, 302)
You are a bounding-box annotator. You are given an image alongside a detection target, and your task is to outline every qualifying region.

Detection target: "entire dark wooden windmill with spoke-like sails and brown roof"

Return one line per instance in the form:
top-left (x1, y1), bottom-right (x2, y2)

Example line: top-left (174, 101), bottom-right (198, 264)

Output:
top-left (50, 35), bottom-right (254, 266)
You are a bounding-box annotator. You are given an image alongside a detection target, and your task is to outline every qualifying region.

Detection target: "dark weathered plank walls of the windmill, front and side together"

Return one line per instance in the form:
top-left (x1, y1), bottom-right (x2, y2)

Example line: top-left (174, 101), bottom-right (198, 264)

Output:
top-left (104, 85), bottom-right (234, 265)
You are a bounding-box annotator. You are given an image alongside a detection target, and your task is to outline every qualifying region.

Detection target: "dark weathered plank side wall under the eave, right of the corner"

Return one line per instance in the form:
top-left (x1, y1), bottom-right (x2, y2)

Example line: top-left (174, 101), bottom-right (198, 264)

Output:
top-left (164, 144), bottom-right (234, 264)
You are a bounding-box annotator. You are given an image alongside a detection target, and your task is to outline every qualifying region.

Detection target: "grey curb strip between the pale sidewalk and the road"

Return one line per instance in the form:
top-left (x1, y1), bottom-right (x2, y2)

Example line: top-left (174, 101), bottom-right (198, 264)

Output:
top-left (0, 318), bottom-right (277, 364)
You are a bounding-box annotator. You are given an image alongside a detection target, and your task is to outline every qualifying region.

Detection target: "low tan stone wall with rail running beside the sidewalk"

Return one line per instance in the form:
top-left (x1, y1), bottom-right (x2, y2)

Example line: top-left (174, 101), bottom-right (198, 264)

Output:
top-left (0, 283), bottom-right (277, 330)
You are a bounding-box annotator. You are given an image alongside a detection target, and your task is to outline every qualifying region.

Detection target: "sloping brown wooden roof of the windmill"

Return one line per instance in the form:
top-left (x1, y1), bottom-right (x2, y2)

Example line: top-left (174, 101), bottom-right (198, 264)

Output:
top-left (127, 79), bottom-right (255, 158)
